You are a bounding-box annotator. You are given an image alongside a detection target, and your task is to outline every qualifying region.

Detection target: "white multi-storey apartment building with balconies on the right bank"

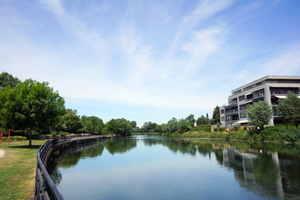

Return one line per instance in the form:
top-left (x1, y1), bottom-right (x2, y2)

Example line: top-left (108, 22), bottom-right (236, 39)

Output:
top-left (220, 76), bottom-right (300, 127)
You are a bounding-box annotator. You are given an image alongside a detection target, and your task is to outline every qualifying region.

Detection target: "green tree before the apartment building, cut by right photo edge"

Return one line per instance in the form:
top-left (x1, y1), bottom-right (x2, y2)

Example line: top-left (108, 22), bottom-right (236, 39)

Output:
top-left (277, 92), bottom-right (300, 128)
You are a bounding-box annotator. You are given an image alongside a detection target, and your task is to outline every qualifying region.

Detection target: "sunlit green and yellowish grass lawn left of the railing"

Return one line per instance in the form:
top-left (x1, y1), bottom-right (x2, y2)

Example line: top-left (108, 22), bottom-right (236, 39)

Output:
top-left (0, 140), bottom-right (46, 200)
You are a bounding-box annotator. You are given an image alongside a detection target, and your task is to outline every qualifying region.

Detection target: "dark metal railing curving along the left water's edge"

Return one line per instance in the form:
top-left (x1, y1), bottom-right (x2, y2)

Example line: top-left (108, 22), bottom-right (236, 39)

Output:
top-left (34, 135), bottom-right (106, 200)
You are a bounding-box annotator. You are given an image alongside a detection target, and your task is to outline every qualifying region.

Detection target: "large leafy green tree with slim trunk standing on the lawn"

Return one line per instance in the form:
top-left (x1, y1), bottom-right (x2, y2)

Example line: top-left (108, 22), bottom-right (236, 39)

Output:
top-left (0, 79), bottom-right (65, 146)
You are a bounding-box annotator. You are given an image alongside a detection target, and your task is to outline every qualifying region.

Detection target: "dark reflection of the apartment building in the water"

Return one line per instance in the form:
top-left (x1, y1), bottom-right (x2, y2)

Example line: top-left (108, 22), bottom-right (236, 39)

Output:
top-left (223, 148), bottom-right (300, 199)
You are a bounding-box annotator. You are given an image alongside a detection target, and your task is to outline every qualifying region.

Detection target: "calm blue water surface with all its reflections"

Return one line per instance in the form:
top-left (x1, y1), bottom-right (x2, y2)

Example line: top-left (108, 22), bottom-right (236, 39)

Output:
top-left (50, 136), bottom-right (300, 200)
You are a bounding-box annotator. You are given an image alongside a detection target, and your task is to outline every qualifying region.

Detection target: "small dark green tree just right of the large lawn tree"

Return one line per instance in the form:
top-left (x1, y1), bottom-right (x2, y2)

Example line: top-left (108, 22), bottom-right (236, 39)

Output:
top-left (63, 109), bottom-right (83, 133)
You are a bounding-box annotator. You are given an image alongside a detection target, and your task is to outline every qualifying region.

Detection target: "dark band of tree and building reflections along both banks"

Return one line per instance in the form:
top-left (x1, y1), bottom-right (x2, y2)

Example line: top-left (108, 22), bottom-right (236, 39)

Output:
top-left (48, 136), bottom-right (300, 199)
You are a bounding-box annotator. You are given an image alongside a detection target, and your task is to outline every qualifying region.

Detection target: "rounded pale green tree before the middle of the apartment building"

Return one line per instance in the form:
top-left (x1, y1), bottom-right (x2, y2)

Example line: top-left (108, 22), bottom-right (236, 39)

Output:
top-left (247, 101), bottom-right (272, 130)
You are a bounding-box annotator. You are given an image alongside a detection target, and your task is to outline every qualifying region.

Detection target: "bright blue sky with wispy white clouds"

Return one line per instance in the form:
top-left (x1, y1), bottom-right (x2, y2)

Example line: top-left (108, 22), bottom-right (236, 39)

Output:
top-left (0, 0), bottom-right (300, 126)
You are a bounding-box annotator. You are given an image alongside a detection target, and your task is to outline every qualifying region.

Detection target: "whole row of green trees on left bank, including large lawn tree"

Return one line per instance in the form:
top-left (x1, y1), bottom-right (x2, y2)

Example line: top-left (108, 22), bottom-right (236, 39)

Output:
top-left (0, 72), bottom-right (136, 146)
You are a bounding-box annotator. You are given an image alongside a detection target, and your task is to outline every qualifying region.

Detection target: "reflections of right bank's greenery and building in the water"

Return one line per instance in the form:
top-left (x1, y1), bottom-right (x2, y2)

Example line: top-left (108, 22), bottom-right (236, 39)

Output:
top-left (143, 138), bottom-right (300, 199)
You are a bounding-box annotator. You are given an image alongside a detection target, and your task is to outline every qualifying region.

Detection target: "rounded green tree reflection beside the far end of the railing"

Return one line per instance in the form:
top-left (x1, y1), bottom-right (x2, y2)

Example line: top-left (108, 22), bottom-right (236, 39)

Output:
top-left (104, 138), bottom-right (136, 154)
